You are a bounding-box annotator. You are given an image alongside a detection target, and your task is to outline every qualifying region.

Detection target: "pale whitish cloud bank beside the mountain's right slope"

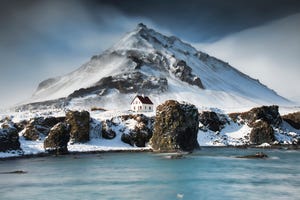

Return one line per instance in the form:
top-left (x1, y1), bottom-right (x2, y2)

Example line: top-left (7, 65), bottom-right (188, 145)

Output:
top-left (195, 13), bottom-right (300, 102)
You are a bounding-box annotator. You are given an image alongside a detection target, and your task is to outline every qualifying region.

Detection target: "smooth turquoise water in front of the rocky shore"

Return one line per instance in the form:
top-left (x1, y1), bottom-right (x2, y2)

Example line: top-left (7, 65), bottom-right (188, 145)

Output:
top-left (0, 148), bottom-right (300, 200)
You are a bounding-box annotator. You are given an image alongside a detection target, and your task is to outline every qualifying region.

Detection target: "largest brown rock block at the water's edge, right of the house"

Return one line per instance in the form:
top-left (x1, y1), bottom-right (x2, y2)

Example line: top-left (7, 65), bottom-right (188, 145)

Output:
top-left (150, 100), bottom-right (199, 152)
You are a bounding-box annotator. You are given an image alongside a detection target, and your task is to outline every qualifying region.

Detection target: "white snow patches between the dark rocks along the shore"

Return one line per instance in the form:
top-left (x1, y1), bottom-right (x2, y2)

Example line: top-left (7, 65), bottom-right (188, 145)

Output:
top-left (0, 107), bottom-right (300, 158)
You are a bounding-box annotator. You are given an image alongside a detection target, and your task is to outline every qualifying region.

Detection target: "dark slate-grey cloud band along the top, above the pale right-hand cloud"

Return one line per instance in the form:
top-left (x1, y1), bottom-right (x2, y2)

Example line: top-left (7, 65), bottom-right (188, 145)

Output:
top-left (85, 0), bottom-right (300, 41)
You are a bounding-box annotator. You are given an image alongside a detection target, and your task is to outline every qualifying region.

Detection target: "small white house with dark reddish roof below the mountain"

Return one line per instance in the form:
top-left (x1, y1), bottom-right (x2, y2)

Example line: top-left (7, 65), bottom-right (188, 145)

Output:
top-left (131, 95), bottom-right (153, 112)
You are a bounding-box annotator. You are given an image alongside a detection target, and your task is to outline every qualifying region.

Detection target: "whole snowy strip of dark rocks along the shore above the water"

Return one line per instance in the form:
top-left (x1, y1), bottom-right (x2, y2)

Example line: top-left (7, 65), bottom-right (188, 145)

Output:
top-left (0, 100), bottom-right (300, 156)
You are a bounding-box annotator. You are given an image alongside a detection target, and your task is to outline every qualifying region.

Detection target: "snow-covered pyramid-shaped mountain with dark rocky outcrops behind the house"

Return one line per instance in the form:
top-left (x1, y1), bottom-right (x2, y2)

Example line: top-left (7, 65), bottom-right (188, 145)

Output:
top-left (22, 24), bottom-right (289, 110)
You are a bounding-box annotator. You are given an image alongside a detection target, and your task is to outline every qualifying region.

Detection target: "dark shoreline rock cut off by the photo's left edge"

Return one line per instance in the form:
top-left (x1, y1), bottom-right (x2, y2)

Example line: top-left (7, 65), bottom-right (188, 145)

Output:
top-left (0, 122), bottom-right (21, 152)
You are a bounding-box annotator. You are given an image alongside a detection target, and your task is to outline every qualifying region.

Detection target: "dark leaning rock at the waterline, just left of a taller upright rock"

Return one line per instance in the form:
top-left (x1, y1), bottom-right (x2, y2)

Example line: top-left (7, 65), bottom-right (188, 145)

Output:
top-left (44, 122), bottom-right (70, 154)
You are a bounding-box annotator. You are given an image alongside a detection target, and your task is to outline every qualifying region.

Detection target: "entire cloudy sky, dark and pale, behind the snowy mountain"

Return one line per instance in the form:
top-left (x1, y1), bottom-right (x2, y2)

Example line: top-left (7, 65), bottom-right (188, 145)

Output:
top-left (0, 0), bottom-right (300, 108)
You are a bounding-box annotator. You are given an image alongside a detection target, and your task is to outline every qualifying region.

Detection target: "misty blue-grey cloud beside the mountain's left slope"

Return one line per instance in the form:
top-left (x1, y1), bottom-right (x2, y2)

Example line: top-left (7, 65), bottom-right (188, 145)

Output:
top-left (0, 1), bottom-right (167, 108)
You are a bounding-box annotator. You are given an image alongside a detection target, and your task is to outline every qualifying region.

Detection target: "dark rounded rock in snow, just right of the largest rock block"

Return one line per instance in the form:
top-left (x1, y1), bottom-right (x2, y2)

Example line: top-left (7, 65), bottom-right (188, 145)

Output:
top-left (199, 111), bottom-right (226, 132)
